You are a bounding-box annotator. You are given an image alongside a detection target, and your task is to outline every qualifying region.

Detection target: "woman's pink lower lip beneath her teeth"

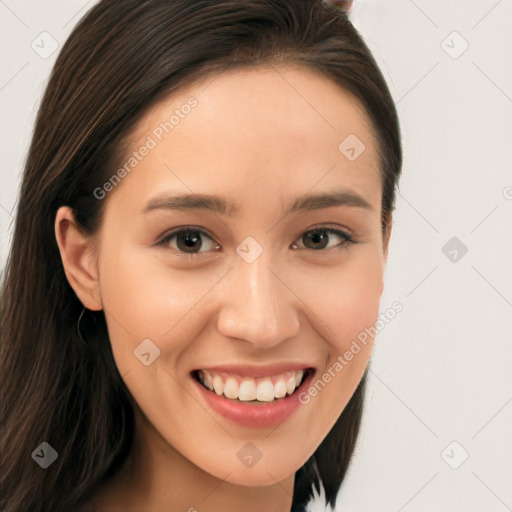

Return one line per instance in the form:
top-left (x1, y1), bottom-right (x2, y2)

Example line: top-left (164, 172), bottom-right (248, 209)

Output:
top-left (191, 372), bottom-right (314, 428)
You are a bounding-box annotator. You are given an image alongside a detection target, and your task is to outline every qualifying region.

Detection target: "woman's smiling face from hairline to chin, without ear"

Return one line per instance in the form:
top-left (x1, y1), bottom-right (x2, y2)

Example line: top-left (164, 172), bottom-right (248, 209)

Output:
top-left (85, 67), bottom-right (385, 486)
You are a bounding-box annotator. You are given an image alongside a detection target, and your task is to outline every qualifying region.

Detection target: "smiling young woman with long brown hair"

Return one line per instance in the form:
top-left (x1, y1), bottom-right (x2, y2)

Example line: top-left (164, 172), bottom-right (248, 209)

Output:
top-left (0, 0), bottom-right (401, 512)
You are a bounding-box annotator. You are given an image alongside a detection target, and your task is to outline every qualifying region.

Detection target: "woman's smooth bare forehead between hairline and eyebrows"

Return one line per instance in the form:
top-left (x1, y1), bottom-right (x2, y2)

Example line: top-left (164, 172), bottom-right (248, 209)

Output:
top-left (114, 66), bottom-right (380, 212)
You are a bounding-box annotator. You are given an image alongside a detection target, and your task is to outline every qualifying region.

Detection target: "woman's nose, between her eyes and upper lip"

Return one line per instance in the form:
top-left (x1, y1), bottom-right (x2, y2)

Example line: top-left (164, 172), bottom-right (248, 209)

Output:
top-left (218, 247), bottom-right (301, 348)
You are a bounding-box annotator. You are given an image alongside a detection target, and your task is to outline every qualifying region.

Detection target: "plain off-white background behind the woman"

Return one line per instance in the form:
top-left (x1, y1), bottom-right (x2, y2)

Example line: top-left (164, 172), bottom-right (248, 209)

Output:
top-left (0, 0), bottom-right (512, 512)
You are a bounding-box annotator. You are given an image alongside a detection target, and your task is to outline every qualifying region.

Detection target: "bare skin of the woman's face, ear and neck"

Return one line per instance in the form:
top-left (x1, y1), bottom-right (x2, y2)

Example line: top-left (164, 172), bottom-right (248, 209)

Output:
top-left (55, 67), bottom-right (391, 512)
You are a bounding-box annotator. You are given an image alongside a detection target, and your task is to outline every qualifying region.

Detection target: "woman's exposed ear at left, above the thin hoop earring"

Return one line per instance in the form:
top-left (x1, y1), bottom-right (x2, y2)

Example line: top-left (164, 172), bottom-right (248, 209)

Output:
top-left (55, 206), bottom-right (103, 311)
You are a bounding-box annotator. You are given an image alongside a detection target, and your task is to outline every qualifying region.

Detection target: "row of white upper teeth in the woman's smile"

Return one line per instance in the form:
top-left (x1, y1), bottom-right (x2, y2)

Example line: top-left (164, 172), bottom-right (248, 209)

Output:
top-left (199, 370), bottom-right (304, 402)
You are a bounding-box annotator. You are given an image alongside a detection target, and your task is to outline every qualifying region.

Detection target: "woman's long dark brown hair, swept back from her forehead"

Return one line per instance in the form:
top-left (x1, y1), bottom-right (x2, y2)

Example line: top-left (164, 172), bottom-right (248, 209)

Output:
top-left (0, 0), bottom-right (402, 512)
